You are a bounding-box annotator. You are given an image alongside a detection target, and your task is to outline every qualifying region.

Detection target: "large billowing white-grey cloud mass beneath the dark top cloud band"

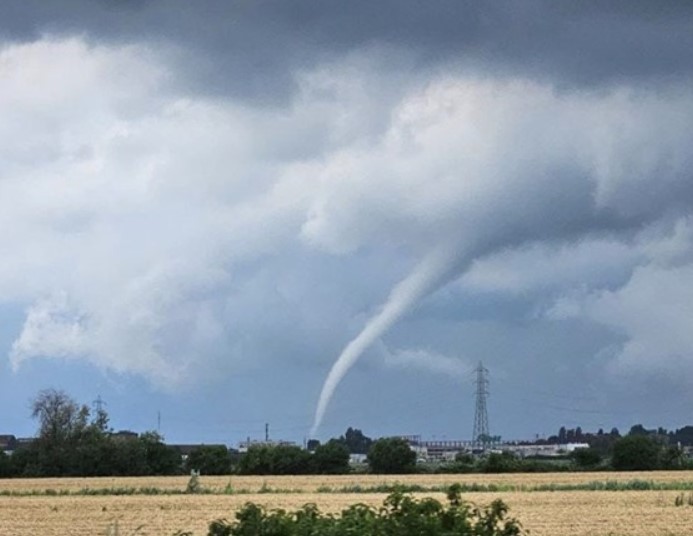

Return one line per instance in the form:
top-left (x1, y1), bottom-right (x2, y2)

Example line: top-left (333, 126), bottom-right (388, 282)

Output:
top-left (0, 38), bottom-right (693, 394)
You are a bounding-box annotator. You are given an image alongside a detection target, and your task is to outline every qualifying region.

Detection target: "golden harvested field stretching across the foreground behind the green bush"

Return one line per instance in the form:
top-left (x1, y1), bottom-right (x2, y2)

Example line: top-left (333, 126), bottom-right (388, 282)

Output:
top-left (0, 472), bottom-right (693, 536)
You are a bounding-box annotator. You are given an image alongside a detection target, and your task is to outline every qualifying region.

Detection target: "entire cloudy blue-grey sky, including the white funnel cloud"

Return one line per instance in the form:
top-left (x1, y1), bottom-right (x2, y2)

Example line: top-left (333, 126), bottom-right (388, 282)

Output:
top-left (0, 0), bottom-right (693, 446)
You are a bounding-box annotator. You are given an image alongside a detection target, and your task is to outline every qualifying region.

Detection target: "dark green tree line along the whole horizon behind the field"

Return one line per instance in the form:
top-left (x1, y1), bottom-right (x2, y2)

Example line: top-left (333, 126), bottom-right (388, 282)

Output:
top-left (0, 389), bottom-right (693, 477)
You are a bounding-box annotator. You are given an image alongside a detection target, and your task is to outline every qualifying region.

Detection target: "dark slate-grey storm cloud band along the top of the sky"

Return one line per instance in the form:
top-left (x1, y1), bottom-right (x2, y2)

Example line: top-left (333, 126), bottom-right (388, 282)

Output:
top-left (0, 0), bottom-right (693, 98)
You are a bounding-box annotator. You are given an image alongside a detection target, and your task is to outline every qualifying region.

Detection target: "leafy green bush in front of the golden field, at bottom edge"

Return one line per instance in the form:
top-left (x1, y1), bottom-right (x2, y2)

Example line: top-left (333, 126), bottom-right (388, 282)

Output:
top-left (208, 485), bottom-right (525, 536)
